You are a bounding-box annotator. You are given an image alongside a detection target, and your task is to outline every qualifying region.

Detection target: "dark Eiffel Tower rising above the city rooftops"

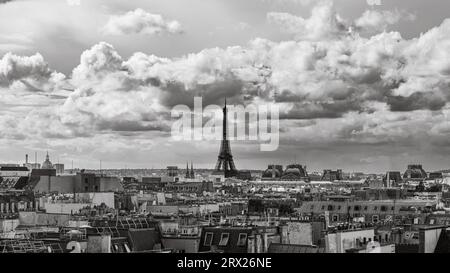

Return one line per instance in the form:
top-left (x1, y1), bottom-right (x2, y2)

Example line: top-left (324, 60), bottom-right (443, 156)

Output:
top-left (215, 99), bottom-right (238, 177)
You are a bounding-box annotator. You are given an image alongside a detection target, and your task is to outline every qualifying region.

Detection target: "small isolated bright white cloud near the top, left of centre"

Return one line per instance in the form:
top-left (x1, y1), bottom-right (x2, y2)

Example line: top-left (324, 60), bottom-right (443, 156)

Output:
top-left (103, 8), bottom-right (183, 35)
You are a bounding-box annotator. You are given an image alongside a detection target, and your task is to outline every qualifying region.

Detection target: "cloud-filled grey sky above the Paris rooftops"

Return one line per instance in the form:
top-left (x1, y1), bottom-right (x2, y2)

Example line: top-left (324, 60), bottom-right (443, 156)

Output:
top-left (0, 0), bottom-right (450, 172)
